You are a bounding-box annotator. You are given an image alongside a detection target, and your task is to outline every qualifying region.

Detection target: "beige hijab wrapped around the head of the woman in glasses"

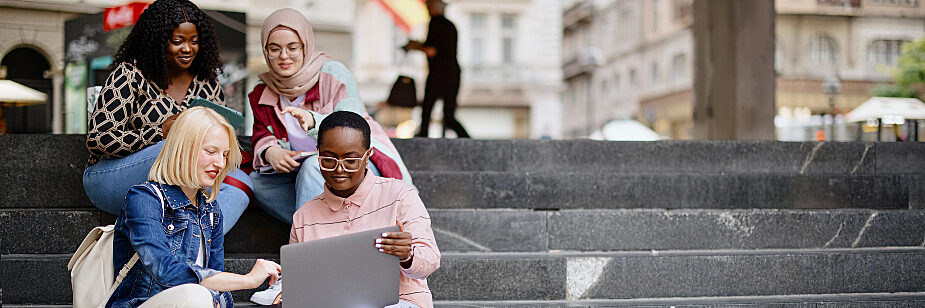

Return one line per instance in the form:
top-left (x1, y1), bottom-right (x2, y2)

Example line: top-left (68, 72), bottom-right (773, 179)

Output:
top-left (257, 8), bottom-right (331, 97)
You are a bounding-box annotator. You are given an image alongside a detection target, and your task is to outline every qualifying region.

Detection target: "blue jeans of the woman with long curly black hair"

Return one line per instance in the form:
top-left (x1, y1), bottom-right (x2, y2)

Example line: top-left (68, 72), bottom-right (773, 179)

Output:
top-left (83, 141), bottom-right (254, 233)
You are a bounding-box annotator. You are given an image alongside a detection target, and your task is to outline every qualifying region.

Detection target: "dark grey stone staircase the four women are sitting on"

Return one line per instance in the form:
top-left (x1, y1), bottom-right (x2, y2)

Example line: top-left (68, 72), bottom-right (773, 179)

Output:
top-left (0, 135), bottom-right (925, 307)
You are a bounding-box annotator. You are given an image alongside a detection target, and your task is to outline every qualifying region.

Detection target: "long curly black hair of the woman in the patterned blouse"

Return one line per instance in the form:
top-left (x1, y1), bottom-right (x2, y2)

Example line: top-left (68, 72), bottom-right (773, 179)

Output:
top-left (110, 0), bottom-right (222, 89)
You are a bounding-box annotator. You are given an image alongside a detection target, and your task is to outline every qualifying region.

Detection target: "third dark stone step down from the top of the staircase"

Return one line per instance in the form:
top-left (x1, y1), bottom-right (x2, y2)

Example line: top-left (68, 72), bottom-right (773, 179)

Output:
top-left (0, 209), bottom-right (925, 255)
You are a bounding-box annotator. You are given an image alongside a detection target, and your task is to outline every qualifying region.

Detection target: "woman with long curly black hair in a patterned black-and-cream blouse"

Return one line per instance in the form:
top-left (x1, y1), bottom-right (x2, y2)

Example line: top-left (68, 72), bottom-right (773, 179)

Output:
top-left (83, 0), bottom-right (252, 232)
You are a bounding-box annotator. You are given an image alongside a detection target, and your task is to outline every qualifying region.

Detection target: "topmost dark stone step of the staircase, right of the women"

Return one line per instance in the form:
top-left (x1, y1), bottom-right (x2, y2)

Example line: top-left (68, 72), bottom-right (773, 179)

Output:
top-left (393, 138), bottom-right (925, 175)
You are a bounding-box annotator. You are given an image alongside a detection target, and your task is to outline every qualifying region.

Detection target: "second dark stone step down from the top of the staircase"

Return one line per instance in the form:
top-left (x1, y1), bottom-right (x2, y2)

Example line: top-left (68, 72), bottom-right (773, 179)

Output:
top-left (0, 168), bottom-right (925, 209)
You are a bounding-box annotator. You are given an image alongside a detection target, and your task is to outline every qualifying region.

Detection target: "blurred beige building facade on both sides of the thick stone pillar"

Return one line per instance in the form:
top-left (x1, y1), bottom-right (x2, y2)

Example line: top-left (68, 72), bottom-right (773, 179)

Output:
top-left (563, 0), bottom-right (925, 139)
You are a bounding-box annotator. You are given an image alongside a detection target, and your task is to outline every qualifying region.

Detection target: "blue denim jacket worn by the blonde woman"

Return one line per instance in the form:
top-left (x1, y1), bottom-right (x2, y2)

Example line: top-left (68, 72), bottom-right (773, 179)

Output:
top-left (106, 182), bottom-right (233, 308)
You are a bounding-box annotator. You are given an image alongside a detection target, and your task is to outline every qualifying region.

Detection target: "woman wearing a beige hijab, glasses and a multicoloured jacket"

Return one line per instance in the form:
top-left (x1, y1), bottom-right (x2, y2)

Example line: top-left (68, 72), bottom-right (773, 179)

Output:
top-left (248, 8), bottom-right (412, 304)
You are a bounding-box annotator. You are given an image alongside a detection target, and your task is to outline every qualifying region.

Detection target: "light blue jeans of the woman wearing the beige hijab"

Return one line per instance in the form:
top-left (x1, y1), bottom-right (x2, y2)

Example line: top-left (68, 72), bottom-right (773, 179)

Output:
top-left (250, 154), bottom-right (380, 224)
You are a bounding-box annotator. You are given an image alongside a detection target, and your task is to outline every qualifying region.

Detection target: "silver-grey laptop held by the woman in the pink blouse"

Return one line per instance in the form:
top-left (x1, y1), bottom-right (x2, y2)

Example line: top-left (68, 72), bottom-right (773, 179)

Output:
top-left (280, 226), bottom-right (401, 308)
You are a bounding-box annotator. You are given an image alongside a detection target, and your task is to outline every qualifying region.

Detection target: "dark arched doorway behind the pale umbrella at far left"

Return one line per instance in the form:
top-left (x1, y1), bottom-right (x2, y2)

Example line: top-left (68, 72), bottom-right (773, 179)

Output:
top-left (0, 47), bottom-right (54, 134)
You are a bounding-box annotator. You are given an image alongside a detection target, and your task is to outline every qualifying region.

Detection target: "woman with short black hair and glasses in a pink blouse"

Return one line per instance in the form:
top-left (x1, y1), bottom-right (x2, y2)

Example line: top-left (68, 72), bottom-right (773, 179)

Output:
top-left (270, 111), bottom-right (440, 308)
